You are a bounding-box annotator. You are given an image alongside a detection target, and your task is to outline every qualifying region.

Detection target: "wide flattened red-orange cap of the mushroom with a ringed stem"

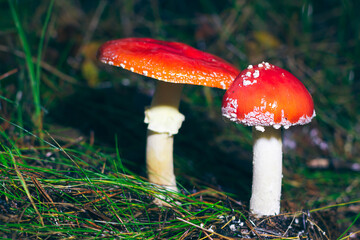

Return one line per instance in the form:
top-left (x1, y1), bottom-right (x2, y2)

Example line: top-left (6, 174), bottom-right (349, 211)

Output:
top-left (97, 38), bottom-right (240, 89)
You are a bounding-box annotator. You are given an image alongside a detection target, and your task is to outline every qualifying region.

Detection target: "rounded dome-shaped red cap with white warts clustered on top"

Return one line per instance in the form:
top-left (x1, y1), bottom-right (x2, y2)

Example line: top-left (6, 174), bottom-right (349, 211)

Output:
top-left (222, 62), bottom-right (315, 128)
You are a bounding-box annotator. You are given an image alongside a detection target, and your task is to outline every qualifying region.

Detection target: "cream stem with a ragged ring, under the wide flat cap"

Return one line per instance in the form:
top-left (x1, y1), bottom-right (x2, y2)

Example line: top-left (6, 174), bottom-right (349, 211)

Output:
top-left (145, 81), bottom-right (185, 191)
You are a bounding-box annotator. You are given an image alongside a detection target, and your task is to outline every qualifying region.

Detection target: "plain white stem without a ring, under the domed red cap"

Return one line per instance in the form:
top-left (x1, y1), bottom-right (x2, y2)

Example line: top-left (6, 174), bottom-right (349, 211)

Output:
top-left (250, 127), bottom-right (282, 217)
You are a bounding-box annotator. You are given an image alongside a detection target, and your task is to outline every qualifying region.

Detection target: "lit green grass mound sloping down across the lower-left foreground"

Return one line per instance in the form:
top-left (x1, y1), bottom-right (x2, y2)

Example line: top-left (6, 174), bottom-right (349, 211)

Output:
top-left (0, 137), bottom-right (338, 239)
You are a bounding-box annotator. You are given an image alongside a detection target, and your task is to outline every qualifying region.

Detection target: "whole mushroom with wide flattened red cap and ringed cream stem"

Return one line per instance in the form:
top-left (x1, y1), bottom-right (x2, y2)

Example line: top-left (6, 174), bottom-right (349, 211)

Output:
top-left (98, 38), bottom-right (240, 191)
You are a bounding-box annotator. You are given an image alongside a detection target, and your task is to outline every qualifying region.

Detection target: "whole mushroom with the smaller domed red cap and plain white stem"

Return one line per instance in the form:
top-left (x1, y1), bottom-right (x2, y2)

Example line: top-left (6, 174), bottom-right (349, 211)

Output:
top-left (222, 62), bottom-right (315, 217)
